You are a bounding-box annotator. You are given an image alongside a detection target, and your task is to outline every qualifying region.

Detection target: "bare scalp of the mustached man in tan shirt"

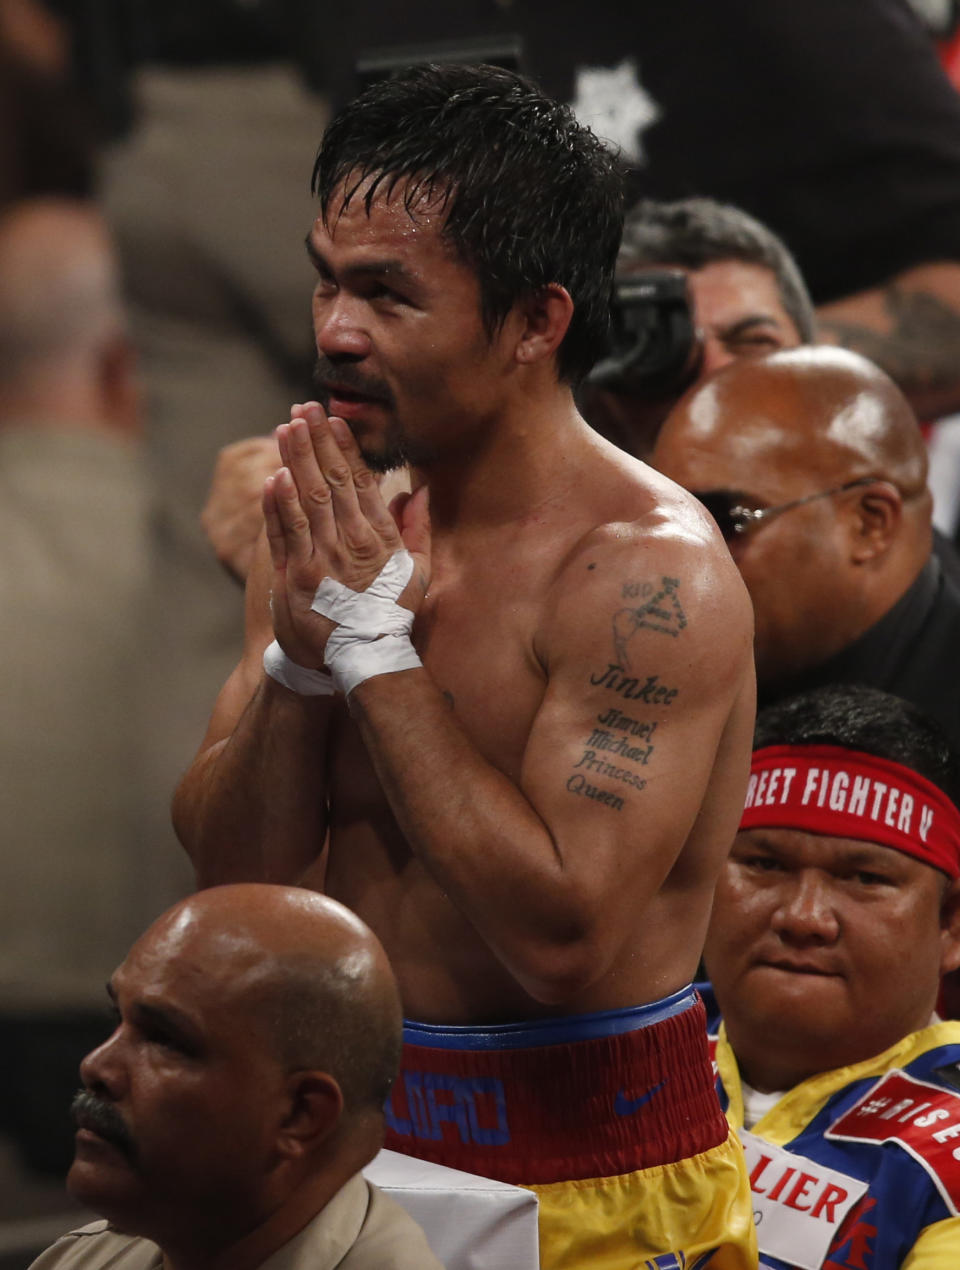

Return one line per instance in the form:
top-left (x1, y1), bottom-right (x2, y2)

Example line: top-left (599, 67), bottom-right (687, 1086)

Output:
top-left (137, 884), bottom-right (403, 1115)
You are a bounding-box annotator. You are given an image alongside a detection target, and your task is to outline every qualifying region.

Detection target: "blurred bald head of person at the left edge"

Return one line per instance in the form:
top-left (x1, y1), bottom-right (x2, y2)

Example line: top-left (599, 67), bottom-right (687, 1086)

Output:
top-left (0, 199), bottom-right (123, 389)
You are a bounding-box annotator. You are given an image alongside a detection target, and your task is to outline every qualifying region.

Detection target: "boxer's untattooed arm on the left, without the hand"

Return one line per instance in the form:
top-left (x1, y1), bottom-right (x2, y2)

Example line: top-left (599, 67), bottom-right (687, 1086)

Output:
top-left (173, 537), bottom-right (334, 886)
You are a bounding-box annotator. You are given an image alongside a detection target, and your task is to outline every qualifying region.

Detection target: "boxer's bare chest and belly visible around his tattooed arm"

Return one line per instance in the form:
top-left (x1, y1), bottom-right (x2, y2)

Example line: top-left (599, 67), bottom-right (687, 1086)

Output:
top-left (326, 523), bottom-right (573, 1021)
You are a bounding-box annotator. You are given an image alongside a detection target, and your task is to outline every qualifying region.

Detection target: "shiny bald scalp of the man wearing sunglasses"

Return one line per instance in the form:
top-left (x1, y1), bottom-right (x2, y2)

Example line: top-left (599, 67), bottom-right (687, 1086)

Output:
top-left (653, 347), bottom-right (927, 498)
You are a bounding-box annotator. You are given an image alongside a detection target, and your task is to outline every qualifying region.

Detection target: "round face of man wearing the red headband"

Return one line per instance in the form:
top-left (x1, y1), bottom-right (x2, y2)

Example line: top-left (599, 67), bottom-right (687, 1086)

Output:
top-left (705, 828), bottom-right (960, 1071)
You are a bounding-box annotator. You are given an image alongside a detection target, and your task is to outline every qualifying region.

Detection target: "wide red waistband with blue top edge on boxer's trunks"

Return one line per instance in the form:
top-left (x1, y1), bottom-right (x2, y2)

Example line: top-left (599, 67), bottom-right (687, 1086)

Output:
top-left (386, 988), bottom-right (728, 1185)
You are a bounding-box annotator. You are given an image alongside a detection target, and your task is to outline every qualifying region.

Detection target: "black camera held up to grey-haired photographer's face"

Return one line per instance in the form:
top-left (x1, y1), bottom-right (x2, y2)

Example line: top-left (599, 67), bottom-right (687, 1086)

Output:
top-left (587, 269), bottom-right (703, 400)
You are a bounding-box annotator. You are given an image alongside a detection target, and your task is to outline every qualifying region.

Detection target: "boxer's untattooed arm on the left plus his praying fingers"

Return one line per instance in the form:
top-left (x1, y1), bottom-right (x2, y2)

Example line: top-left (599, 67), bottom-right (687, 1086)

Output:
top-left (173, 403), bottom-right (427, 886)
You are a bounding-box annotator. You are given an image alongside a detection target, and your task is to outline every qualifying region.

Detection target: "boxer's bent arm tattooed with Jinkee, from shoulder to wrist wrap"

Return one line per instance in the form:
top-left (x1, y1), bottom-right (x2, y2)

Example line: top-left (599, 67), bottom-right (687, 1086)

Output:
top-left (350, 526), bottom-right (752, 1003)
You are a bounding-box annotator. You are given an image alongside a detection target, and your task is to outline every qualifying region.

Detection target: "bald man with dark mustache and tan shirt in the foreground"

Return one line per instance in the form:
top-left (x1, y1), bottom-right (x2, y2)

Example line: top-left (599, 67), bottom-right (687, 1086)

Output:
top-left (34, 884), bottom-right (442, 1270)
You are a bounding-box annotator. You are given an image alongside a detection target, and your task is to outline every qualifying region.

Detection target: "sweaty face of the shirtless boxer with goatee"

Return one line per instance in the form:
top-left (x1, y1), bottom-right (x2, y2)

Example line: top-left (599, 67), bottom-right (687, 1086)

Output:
top-left (307, 185), bottom-right (525, 470)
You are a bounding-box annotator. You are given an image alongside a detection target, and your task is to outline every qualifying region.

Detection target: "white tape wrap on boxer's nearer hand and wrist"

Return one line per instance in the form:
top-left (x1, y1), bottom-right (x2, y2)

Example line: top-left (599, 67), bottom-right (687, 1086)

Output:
top-left (310, 549), bottom-right (423, 696)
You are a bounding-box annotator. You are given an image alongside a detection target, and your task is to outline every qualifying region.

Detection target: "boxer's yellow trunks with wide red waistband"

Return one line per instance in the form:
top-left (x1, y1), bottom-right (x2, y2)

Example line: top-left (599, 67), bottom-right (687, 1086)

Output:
top-left (386, 988), bottom-right (757, 1270)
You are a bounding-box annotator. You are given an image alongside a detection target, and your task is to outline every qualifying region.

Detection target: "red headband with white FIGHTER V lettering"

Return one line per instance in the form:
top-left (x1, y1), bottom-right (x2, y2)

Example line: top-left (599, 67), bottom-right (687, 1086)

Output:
top-left (740, 745), bottom-right (960, 878)
